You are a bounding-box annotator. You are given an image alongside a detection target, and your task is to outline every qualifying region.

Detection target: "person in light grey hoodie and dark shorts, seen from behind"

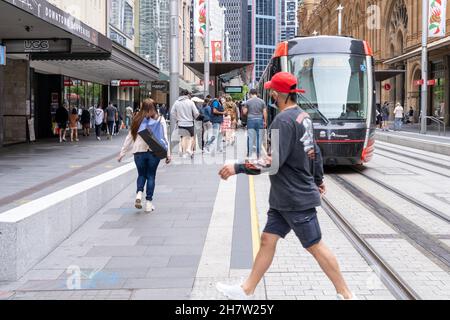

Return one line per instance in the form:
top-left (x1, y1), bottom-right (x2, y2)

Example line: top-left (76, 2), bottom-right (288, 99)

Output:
top-left (170, 90), bottom-right (200, 158)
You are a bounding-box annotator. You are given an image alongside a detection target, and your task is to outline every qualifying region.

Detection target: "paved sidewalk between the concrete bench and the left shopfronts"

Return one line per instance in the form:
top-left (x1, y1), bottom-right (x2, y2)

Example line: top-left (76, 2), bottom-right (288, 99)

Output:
top-left (0, 130), bottom-right (126, 214)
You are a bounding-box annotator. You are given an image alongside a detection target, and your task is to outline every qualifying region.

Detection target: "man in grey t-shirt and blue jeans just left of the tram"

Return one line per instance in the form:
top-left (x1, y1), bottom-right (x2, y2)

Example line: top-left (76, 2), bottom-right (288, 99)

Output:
top-left (243, 89), bottom-right (267, 159)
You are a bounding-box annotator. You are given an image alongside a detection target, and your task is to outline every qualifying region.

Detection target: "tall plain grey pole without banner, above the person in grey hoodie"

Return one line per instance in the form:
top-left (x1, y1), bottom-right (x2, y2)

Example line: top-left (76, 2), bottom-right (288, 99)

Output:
top-left (169, 0), bottom-right (180, 108)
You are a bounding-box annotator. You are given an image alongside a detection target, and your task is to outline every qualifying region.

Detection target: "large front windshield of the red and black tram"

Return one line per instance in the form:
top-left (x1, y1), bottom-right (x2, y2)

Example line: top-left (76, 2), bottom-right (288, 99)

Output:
top-left (288, 54), bottom-right (370, 121)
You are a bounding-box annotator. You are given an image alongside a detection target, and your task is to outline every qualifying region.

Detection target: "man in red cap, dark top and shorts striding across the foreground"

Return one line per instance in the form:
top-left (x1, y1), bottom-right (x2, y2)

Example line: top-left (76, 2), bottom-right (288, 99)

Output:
top-left (216, 72), bottom-right (356, 300)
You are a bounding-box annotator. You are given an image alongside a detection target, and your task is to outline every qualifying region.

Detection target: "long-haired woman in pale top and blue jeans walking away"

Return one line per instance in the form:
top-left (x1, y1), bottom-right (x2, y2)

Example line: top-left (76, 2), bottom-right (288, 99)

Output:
top-left (118, 99), bottom-right (171, 213)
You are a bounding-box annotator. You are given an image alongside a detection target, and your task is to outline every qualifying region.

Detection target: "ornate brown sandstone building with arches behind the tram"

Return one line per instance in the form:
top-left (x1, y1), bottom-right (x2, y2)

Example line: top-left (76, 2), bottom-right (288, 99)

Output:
top-left (298, 0), bottom-right (450, 124)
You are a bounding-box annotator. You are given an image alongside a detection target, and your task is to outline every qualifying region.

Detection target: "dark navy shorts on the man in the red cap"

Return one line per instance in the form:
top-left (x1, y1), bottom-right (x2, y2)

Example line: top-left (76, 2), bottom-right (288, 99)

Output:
top-left (264, 208), bottom-right (322, 249)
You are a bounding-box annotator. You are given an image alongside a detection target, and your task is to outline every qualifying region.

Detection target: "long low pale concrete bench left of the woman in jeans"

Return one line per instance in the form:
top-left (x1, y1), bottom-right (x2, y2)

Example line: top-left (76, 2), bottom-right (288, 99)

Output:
top-left (0, 163), bottom-right (135, 281)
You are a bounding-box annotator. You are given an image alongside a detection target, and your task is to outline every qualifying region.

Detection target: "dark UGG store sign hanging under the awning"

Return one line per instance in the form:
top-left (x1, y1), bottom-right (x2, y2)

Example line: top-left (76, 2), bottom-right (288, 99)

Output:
top-left (3, 39), bottom-right (71, 53)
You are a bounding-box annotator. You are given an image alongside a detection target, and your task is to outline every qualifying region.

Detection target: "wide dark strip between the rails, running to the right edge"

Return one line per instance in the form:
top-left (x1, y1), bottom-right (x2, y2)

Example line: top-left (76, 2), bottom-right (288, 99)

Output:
top-left (328, 174), bottom-right (450, 271)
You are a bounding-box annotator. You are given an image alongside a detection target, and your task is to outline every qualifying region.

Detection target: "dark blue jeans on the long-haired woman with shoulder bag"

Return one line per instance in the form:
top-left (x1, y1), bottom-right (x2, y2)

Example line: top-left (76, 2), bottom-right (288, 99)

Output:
top-left (134, 152), bottom-right (161, 201)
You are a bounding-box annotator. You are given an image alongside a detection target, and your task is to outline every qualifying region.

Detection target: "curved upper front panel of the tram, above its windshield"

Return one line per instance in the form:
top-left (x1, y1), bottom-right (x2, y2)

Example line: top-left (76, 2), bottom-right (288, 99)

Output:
top-left (285, 36), bottom-right (372, 55)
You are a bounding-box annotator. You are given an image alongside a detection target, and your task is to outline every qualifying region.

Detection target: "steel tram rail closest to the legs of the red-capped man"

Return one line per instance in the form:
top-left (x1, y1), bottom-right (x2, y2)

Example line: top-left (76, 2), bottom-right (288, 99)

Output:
top-left (322, 197), bottom-right (421, 300)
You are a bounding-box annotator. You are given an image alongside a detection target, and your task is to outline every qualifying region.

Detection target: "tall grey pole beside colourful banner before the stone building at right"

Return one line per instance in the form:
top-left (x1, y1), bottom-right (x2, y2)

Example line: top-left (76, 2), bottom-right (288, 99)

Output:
top-left (420, 0), bottom-right (428, 134)
